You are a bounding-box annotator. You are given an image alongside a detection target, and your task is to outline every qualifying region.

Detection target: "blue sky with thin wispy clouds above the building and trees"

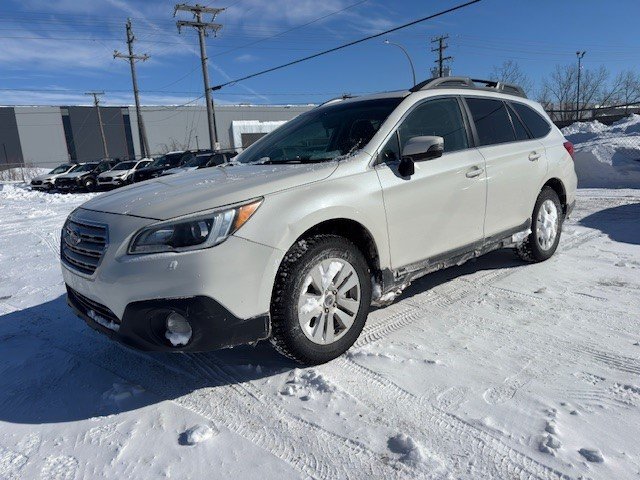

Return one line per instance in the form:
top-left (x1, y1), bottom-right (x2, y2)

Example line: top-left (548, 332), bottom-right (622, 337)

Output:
top-left (0, 0), bottom-right (640, 105)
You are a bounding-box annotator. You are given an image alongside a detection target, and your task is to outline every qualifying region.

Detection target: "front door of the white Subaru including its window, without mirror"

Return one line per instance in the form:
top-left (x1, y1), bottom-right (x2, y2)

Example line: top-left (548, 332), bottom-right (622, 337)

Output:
top-left (376, 97), bottom-right (487, 269)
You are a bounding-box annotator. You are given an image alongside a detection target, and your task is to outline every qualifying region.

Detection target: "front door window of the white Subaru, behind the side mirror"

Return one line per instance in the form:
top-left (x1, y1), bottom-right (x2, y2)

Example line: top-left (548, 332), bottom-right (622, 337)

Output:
top-left (398, 98), bottom-right (469, 152)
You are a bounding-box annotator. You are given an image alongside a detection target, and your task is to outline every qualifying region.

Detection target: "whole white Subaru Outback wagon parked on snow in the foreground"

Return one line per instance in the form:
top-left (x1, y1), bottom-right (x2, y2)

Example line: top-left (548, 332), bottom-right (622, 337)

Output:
top-left (61, 77), bottom-right (577, 364)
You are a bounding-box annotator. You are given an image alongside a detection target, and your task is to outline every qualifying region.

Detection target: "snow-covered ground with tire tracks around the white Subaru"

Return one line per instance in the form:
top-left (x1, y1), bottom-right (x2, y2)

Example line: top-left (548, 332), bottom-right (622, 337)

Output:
top-left (0, 150), bottom-right (640, 480)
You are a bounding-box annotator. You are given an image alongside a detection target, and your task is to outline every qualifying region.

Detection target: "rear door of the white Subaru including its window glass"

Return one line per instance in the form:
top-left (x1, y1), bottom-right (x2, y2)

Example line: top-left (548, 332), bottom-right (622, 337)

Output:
top-left (465, 96), bottom-right (547, 238)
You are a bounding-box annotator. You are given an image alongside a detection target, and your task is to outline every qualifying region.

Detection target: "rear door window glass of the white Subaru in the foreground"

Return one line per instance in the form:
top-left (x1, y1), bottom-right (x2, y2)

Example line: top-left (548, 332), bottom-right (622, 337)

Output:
top-left (466, 98), bottom-right (516, 145)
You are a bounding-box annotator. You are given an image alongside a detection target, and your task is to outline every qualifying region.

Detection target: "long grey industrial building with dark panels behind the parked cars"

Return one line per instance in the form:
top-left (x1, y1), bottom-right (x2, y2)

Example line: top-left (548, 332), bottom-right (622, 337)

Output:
top-left (0, 105), bottom-right (313, 167)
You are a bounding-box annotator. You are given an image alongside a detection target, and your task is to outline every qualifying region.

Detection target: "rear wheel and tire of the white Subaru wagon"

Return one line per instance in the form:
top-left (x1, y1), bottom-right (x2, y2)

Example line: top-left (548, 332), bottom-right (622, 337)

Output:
top-left (516, 187), bottom-right (564, 263)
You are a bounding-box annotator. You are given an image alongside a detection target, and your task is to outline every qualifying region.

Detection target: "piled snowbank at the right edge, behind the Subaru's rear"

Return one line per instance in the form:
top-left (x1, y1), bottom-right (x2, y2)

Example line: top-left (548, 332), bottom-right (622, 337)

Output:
top-left (562, 115), bottom-right (640, 188)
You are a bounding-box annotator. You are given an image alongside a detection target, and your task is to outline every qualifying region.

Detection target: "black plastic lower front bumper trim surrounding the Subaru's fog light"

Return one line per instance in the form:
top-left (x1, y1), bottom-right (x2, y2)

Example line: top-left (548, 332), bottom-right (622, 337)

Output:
top-left (67, 286), bottom-right (269, 352)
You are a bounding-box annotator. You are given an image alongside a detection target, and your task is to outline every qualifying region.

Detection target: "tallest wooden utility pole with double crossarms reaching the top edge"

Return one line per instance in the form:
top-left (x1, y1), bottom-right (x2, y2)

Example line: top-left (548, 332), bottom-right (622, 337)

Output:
top-left (173, 3), bottom-right (224, 150)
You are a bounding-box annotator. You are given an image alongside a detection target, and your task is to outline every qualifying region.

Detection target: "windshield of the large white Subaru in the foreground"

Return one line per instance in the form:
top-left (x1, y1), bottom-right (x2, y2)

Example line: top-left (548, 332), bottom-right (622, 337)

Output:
top-left (236, 97), bottom-right (402, 163)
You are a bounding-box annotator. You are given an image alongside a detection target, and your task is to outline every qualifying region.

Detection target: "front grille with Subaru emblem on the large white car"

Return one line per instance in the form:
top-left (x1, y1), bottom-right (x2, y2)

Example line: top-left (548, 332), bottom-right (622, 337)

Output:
top-left (60, 218), bottom-right (108, 275)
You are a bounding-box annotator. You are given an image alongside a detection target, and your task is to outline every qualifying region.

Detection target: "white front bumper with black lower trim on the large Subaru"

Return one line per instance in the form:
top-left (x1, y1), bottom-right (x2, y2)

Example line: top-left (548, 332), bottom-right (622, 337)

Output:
top-left (62, 208), bottom-right (284, 351)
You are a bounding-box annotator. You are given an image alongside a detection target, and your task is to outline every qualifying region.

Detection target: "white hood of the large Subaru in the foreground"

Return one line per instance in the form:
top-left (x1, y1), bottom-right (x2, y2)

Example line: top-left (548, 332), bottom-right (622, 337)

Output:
top-left (81, 162), bottom-right (337, 220)
